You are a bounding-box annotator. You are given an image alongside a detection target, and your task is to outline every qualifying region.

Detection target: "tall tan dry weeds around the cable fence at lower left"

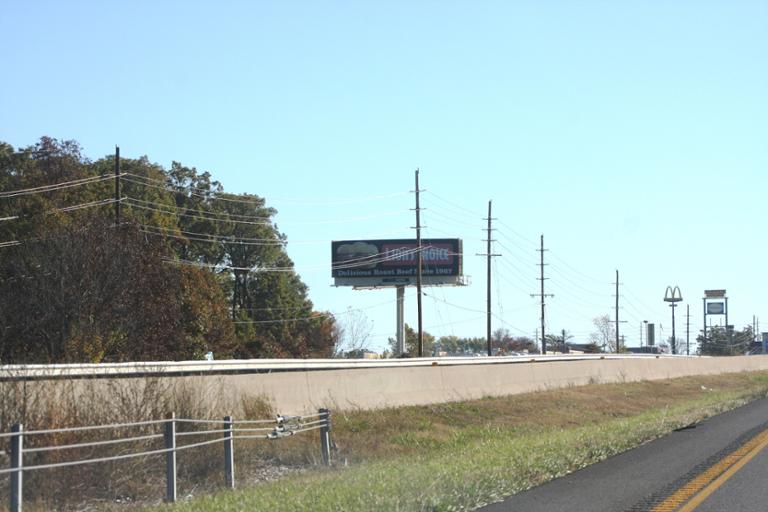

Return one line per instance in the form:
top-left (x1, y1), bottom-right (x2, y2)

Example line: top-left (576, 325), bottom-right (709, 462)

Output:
top-left (0, 378), bottom-right (292, 510)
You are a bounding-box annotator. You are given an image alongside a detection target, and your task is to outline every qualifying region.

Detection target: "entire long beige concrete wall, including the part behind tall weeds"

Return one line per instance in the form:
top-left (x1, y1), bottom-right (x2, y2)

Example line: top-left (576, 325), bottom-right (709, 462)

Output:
top-left (6, 356), bottom-right (768, 414)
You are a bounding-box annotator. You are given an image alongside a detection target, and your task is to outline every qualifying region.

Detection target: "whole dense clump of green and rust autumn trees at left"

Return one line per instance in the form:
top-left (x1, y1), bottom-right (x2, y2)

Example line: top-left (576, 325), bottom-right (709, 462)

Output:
top-left (0, 138), bottom-right (338, 363)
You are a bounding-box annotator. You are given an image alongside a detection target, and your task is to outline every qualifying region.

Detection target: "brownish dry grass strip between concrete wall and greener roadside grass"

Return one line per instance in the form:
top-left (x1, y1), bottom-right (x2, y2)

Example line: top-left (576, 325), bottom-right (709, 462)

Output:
top-left (333, 373), bottom-right (768, 463)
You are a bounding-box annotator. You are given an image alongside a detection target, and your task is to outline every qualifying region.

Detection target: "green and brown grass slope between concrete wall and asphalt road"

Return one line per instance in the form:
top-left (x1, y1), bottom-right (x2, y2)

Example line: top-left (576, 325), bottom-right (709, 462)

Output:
top-left (152, 372), bottom-right (768, 512)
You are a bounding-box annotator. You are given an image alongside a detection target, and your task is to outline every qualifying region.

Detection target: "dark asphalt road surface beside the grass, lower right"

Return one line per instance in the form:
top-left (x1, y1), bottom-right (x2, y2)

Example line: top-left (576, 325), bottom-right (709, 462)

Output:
top-left (480, 399), bottom-right (768, 512)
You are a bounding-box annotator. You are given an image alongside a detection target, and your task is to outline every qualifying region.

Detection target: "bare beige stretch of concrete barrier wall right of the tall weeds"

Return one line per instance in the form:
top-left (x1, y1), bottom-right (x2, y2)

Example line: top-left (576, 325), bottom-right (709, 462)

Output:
top-left (189, 356), bottom-right (768, 413)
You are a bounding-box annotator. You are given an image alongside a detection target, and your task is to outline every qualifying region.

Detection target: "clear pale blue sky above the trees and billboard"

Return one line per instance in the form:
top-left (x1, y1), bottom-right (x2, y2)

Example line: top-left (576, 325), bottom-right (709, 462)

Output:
top-left (0, 1), bottom-right (768, 349)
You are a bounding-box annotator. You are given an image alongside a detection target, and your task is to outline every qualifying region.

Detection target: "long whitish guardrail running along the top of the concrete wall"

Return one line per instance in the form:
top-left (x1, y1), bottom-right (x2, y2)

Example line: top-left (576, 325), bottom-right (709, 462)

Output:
top-left (0, 354), bottom-right (680, 380)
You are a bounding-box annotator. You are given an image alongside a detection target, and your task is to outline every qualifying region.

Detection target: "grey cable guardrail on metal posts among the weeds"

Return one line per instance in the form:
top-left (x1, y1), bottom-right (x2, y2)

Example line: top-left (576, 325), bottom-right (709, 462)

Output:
top-left (0, 409), bottom-right (331, 512)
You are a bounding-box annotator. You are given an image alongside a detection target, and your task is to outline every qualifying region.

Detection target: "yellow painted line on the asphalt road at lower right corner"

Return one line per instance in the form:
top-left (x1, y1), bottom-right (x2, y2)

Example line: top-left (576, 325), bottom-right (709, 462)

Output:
top-left (652, 429), bottom-right (768, 512)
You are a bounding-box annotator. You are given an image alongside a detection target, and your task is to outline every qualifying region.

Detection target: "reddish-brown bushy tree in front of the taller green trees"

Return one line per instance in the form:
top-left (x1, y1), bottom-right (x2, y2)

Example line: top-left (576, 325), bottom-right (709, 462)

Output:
top-left (0, 219), bottom-right (234, 363)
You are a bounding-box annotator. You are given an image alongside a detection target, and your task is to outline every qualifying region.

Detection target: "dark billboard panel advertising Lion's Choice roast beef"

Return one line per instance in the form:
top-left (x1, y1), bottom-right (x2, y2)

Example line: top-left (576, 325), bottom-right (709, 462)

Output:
top-left (331, 238), bottom-right (463, 286)
